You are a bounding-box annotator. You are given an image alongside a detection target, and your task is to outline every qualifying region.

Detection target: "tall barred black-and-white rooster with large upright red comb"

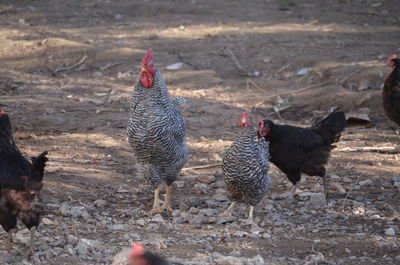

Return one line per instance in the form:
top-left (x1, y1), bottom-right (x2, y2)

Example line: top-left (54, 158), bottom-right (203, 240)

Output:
top-left (128, 49), bottom-right (189, 214)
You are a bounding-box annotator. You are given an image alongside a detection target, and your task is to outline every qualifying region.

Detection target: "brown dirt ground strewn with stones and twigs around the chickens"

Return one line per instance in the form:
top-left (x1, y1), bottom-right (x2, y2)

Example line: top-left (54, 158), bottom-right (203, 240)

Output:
top-left (0, 0), bottom-right (400, 265)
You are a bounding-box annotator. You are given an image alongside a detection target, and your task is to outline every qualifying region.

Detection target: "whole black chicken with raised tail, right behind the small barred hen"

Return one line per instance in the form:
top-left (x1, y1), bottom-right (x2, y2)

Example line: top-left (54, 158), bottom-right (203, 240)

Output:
top-left (258, 109), bottom-right (346, 198)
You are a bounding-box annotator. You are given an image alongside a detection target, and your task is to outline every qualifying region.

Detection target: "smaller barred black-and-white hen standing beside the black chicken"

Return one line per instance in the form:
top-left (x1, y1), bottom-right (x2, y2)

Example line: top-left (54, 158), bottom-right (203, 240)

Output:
top-left (221, 112), bottom-right (272, 221)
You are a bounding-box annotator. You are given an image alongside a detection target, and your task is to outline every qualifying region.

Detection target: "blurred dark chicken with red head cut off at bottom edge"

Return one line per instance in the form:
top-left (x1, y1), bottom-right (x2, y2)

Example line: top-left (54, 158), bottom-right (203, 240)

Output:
top-left (129, 243), bottom-right (169, 265)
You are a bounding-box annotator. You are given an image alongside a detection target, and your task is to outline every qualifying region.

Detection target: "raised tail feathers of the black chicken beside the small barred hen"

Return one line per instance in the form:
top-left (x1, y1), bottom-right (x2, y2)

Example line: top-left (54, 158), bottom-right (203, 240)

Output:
top-left (313, 108), bottom-right (347, 144)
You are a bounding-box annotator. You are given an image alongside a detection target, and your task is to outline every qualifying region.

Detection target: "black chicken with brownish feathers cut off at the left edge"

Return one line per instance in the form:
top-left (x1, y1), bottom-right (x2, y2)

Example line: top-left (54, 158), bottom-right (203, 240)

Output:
top-left (0, 110), bottom-right (47, 250)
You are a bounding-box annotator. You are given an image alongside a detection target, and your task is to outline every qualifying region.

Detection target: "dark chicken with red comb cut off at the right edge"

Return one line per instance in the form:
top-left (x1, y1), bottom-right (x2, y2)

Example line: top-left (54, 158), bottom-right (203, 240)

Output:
top-left (382, 55), bottom-right (400, 126)
